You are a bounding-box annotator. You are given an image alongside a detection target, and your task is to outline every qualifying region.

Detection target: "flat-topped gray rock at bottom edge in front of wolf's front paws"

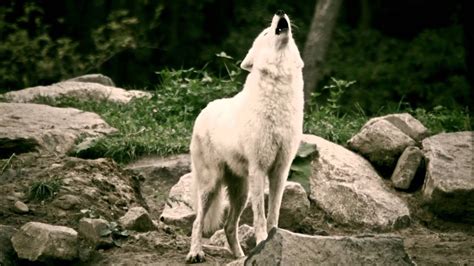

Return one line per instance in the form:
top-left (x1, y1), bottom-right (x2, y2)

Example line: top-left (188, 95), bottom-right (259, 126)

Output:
top-left (239, 228), bottom-right (415, 265)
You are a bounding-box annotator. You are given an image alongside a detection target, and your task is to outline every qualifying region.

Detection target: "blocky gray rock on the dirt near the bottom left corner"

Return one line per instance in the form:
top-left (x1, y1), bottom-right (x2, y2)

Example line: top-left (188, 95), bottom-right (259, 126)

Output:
top-left (12, 222), bottom-right (78, 261)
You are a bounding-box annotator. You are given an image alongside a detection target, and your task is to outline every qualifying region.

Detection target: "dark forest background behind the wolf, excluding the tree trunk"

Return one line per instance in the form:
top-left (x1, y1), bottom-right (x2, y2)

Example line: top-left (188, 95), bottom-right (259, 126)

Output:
top-left (0, 0), bottom-right (473, 114)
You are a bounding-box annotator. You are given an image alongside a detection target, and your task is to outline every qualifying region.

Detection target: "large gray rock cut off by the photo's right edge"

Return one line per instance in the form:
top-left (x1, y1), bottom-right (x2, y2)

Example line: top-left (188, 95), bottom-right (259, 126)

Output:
top-left (422, 131), bottom-right (474, 223)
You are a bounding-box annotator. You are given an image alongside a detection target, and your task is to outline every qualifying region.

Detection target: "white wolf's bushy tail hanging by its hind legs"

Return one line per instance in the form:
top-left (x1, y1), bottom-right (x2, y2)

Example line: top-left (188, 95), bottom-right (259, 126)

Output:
top-left (192, 171), bottom-right (226, 234)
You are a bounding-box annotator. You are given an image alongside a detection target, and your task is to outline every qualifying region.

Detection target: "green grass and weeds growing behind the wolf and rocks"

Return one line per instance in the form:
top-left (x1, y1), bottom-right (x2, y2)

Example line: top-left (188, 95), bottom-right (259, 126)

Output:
top-left (32, 68), bottom-right (471, 163)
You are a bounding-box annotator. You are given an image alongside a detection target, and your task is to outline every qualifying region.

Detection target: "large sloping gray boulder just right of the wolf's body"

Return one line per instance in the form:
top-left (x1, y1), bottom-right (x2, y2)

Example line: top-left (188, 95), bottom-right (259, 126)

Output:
top-left (303, 135), bottom-right (410, 231)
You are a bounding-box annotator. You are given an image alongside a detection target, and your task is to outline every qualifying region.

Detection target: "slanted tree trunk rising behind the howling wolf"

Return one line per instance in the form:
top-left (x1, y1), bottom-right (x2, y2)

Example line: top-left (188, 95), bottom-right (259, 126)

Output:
top-left (303, 0), bottom-right (342, 105)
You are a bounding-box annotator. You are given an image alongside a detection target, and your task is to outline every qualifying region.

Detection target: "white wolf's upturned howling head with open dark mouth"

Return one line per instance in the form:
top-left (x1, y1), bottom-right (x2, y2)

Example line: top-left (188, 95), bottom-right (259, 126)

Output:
top-left (240, 10), bottom-right (303, 72)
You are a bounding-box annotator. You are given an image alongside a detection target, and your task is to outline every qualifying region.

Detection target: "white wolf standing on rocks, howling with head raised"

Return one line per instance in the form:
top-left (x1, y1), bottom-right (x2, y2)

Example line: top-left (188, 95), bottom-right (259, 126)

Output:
top-left (186, 11), bottom-right (304, 262)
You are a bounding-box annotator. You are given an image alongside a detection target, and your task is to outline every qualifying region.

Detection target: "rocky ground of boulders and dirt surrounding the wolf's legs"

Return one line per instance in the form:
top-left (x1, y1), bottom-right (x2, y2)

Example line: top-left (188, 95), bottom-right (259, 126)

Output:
top-left (0, 77), bottom-right (474, 265)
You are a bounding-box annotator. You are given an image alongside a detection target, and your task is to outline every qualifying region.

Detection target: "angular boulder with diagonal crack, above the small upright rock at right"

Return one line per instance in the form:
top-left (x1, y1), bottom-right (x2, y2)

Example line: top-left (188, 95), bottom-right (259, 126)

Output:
top-left (347, 113), bottom-right (428, 171)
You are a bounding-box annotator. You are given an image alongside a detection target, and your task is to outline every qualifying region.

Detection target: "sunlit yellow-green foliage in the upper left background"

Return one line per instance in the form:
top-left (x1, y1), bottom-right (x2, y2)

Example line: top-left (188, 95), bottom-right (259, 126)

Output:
top-left (0, 1), bottom-right (159, 90)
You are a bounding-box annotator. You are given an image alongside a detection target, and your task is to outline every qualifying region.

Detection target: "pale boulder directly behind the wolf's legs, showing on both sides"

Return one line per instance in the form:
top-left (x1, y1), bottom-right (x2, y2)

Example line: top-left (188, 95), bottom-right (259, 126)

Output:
top-left (160, 174), bottom-right (310, 234)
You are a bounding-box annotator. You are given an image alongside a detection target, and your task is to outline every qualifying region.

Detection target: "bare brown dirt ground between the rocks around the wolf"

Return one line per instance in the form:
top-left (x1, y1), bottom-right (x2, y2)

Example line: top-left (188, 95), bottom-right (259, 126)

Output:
top-left (0, 153), bottom-right (474, 265)
